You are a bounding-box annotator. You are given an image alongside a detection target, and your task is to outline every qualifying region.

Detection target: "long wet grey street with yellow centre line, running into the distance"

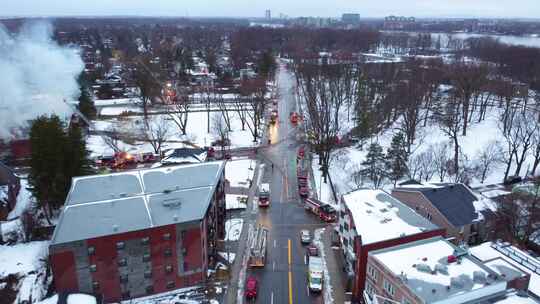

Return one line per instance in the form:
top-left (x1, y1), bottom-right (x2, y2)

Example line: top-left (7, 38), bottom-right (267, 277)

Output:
top-left (247, 66), bottom-right (324, 303)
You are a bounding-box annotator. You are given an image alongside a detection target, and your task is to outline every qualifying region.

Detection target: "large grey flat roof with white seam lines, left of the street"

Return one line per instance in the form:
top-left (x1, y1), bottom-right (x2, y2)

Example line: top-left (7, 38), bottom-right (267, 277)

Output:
top-left (52, 161), bottom-right (225, 244)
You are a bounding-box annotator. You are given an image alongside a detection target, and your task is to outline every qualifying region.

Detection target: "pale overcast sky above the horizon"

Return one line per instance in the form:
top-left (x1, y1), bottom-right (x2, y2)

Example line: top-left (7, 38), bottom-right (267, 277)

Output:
top-left (0, 0), bottom-right (540, 18)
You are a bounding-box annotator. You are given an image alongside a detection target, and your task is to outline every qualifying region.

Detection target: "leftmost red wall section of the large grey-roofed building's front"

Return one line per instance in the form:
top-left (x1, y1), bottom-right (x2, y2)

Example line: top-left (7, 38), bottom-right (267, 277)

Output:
top-left (50, 251), bottom-right (79, 291)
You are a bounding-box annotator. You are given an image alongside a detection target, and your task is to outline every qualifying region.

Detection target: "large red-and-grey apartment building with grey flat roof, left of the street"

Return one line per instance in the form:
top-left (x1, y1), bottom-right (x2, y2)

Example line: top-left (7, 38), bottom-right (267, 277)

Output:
top-left (49, 162), bottom-right (225, 302)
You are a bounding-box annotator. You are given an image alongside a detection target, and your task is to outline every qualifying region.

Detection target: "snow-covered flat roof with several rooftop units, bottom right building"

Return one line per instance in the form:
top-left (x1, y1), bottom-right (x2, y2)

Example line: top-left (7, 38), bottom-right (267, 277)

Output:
top-left (369, 237), bottom-right (506, 303)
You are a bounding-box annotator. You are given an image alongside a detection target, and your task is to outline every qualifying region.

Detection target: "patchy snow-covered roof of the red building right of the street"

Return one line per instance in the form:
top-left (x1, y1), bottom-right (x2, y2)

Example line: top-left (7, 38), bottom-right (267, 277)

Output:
top-left (342, 189), bottom-right (438, 244)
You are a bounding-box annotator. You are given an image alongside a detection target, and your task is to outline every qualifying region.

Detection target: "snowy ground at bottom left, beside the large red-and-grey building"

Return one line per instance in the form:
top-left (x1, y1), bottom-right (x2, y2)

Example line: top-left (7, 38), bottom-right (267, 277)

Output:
top-left (0, 241), bottom-right (50, 303)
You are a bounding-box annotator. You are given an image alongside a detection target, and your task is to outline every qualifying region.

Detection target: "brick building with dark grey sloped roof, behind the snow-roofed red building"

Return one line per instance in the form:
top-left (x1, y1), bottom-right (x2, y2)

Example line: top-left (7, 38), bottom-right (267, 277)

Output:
top-left (392, 183), bottom-right (496, 244)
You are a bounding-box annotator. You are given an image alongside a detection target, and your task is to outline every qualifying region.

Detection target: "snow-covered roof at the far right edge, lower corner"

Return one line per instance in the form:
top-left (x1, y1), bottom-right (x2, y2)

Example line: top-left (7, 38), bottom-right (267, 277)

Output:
top-left (470, 242), bottom-right (540, 296)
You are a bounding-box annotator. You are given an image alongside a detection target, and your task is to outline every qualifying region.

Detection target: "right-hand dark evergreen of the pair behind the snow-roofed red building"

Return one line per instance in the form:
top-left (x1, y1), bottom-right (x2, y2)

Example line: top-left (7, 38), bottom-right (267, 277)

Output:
top-left (386, 132), bottom-right (409, 186)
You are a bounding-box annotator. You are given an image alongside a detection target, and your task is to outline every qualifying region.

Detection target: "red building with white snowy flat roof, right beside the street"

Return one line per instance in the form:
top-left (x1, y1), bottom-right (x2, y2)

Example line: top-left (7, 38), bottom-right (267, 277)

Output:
top-left (338, 189), bottom-right (445, 301)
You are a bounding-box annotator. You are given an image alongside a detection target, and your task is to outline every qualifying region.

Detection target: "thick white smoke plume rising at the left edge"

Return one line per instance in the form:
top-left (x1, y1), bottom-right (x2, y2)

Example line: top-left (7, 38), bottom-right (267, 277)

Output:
top-left (0, 22), bottom-right (84, 139)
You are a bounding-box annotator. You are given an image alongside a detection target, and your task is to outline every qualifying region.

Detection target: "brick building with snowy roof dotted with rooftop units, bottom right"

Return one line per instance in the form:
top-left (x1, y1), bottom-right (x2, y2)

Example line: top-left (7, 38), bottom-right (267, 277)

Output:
top-left (365, 236), bottom-right (509, 304)
